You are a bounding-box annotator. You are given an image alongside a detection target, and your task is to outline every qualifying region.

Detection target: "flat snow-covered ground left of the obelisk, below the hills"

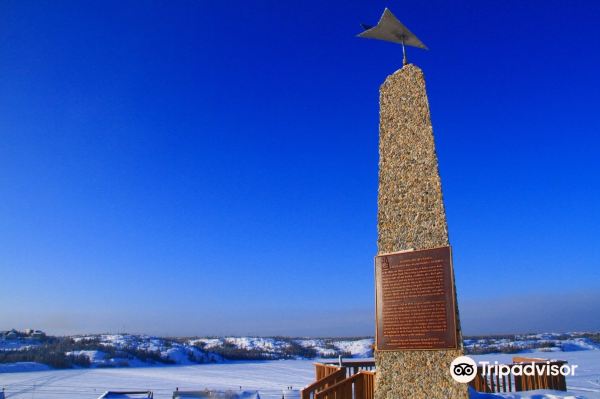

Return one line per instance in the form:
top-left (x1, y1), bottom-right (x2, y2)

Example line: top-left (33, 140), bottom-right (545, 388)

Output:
top-left (0, 360), bottom-right (314, 399)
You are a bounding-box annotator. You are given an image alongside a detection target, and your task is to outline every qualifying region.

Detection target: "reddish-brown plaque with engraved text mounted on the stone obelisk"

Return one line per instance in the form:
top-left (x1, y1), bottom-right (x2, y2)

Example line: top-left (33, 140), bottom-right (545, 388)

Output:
top-left (375, 247), bottom-right (457, 350)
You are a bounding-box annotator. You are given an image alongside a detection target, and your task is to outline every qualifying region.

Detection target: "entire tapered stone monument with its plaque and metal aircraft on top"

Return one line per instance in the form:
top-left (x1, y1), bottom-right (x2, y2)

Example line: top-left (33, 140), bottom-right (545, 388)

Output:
top-left (359, 9), bottom-right (468, 399)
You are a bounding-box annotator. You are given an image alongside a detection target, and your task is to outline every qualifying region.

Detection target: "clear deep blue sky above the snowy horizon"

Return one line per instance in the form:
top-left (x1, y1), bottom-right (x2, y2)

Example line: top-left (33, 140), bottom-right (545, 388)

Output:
top-left (0, 0), bottom-right (600, 335)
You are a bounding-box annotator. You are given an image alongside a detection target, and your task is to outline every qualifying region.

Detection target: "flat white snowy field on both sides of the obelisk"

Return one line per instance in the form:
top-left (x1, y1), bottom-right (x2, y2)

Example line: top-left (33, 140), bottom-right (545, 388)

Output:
top-left (0, 350), bottom-right (600, 399)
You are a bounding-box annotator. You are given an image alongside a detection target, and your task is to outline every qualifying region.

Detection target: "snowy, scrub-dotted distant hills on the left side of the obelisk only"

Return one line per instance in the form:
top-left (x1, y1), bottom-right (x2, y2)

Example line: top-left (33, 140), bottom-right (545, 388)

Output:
top-left (0, 330), bottom-right (373, 368)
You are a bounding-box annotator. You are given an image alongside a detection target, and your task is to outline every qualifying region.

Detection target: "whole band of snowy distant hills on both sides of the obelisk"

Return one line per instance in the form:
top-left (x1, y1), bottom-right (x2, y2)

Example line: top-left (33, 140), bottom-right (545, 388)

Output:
top-left (0, 330), bottom-right (600, 370)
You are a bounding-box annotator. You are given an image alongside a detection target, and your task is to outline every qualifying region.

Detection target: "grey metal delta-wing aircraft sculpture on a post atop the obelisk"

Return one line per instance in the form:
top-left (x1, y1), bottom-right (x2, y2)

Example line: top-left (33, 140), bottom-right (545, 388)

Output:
top-left (357, 8), bottom-right (428, 65)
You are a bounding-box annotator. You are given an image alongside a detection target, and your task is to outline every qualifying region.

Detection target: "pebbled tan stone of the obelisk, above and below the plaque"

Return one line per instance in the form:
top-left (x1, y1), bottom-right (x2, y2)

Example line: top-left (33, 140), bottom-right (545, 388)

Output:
top-left (375, 64), bottom-right (468, 399)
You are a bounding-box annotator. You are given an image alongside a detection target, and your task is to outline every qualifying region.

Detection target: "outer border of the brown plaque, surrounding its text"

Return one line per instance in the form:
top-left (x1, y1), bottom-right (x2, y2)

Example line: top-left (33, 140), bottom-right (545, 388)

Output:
top-left (374, 245), bottom-right (461, 352)
